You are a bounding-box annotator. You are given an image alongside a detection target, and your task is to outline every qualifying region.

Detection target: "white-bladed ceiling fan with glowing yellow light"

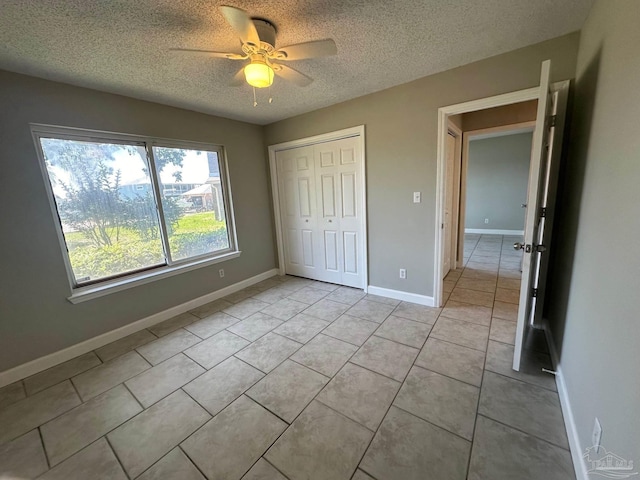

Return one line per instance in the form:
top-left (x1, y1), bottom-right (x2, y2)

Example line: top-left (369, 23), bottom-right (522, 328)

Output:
top-left (171, 5), bottom-right (338, 92)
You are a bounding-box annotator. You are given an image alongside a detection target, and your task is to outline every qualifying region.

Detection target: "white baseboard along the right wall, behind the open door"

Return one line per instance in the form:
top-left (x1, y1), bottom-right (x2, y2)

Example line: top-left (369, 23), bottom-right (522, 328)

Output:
top-left (543, 319), bottom-right (588, 480)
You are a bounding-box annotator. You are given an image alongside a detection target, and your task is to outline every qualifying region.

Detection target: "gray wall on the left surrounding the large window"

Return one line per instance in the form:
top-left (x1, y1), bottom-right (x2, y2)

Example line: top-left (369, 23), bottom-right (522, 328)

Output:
top-left (0, 71), bottom-right (275, 371)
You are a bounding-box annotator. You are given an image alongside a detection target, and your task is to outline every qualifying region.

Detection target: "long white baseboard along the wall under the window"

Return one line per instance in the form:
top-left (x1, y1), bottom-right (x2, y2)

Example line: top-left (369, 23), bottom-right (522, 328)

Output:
top-left (0, 268), bottom-right (279, 387)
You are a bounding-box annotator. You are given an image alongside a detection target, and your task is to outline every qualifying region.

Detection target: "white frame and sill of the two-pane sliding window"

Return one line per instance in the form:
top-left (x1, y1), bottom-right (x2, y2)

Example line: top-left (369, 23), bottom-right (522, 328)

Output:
top-left (30, 124), bottom-right (241, 303)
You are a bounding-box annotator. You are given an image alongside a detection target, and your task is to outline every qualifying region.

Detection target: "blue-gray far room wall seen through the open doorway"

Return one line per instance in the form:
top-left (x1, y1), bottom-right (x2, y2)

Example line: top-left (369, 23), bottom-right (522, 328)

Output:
top-left (464, 133), bottom-right (533, 230)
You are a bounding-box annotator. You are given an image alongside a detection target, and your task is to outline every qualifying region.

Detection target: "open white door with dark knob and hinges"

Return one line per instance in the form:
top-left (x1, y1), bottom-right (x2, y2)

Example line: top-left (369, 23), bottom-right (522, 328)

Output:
top-left (513, 60), bottom-right (568, 370)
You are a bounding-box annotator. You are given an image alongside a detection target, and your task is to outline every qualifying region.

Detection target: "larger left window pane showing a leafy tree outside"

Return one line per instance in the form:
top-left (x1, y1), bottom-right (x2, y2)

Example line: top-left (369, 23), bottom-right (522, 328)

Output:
top-left (40, 138), bottom-right (166, 285)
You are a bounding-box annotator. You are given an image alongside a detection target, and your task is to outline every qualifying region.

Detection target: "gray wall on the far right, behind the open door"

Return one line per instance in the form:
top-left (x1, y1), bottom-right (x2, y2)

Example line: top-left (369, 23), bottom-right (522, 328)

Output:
top-left (546, 0), bottom-right (640, 464)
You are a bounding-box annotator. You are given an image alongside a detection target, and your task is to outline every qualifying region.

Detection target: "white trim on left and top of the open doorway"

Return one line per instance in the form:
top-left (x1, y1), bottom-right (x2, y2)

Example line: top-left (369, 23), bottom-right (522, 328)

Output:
top-left (433, 86), bottom-right (540, 307)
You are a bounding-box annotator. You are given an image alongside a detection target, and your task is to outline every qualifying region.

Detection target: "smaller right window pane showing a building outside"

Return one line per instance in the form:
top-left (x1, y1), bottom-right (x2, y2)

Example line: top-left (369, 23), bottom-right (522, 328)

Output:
top-left (153, 147), bottom-right (229, 260)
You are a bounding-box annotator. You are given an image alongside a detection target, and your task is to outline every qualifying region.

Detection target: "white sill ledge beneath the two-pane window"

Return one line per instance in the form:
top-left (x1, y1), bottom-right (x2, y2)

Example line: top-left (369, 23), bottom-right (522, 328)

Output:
top-left (67, 250), bottom-right (242, 304)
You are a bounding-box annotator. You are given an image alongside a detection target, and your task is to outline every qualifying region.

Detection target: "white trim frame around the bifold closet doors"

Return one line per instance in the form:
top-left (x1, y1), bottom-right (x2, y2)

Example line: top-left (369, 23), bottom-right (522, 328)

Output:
top-left (268, 125), bottom-right (369, 293)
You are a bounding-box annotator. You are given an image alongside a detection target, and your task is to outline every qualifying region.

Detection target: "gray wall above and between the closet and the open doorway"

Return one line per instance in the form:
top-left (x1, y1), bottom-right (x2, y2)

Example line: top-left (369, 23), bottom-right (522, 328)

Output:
top-left (265, 33), bottom-right (579, 296)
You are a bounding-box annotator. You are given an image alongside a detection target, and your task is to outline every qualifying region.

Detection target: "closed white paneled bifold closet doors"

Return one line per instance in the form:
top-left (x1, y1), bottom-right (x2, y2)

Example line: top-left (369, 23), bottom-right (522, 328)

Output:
top-left (276, 137), bottom-right (364, 288)
